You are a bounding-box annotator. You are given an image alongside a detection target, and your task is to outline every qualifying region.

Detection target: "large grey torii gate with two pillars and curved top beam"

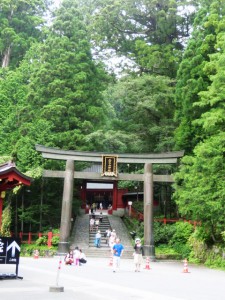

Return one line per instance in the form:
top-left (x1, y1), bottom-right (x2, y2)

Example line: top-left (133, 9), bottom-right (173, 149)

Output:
top-left (36, 145), bottom-right (184, 260)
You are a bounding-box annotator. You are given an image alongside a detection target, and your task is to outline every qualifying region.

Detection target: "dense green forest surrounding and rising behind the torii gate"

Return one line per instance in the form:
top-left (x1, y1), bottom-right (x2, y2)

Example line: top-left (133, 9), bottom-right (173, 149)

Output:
top-left (0, 0), bottom-right (225, 262)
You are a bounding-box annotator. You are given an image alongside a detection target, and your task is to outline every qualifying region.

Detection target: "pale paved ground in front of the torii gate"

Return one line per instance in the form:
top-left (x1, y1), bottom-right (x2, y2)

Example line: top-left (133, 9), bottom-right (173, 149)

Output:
top-left (0, 257), bottom-right (225, 300)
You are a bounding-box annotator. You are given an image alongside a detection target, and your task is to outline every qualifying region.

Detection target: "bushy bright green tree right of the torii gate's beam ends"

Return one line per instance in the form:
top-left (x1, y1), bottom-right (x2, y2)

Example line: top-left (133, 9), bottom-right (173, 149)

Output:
top-left (174, 132), bottom-right (225, 242)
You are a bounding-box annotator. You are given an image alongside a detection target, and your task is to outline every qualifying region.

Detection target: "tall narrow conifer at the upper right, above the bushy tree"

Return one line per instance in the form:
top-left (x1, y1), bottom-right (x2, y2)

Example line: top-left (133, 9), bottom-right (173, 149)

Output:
top-left (175, 1), bottom-right (225, 154)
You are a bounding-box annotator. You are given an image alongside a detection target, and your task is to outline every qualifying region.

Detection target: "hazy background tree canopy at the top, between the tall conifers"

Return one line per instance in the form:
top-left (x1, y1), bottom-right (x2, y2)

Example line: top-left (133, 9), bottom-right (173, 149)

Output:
top-left (81, 0), bottom-right (193, 77)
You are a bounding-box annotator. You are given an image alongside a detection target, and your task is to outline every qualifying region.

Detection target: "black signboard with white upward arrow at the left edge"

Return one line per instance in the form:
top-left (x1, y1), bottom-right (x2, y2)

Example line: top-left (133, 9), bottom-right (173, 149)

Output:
top-left (0, 237), bottom-right (20, 265)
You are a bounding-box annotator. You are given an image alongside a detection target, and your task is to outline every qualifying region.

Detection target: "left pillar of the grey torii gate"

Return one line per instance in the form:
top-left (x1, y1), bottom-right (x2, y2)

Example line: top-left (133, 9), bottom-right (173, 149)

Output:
top-left (58, 160), bottom-right (74, 255)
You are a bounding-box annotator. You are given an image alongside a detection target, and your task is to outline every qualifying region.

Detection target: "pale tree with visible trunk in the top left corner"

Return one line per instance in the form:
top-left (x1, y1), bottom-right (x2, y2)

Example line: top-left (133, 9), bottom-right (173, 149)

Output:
top-left (0, 0), bottom-right (50, 68)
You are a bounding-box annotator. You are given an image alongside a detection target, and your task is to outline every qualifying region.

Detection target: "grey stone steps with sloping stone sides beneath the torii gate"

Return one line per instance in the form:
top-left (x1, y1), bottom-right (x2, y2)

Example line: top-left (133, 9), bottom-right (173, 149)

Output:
top-left (70, 213), bottom-right (133, 258)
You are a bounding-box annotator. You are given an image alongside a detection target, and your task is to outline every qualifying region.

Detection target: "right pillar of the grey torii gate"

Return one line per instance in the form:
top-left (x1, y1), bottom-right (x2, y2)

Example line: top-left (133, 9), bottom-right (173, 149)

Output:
top-left (144, 163), bottom-right (155, 261)
